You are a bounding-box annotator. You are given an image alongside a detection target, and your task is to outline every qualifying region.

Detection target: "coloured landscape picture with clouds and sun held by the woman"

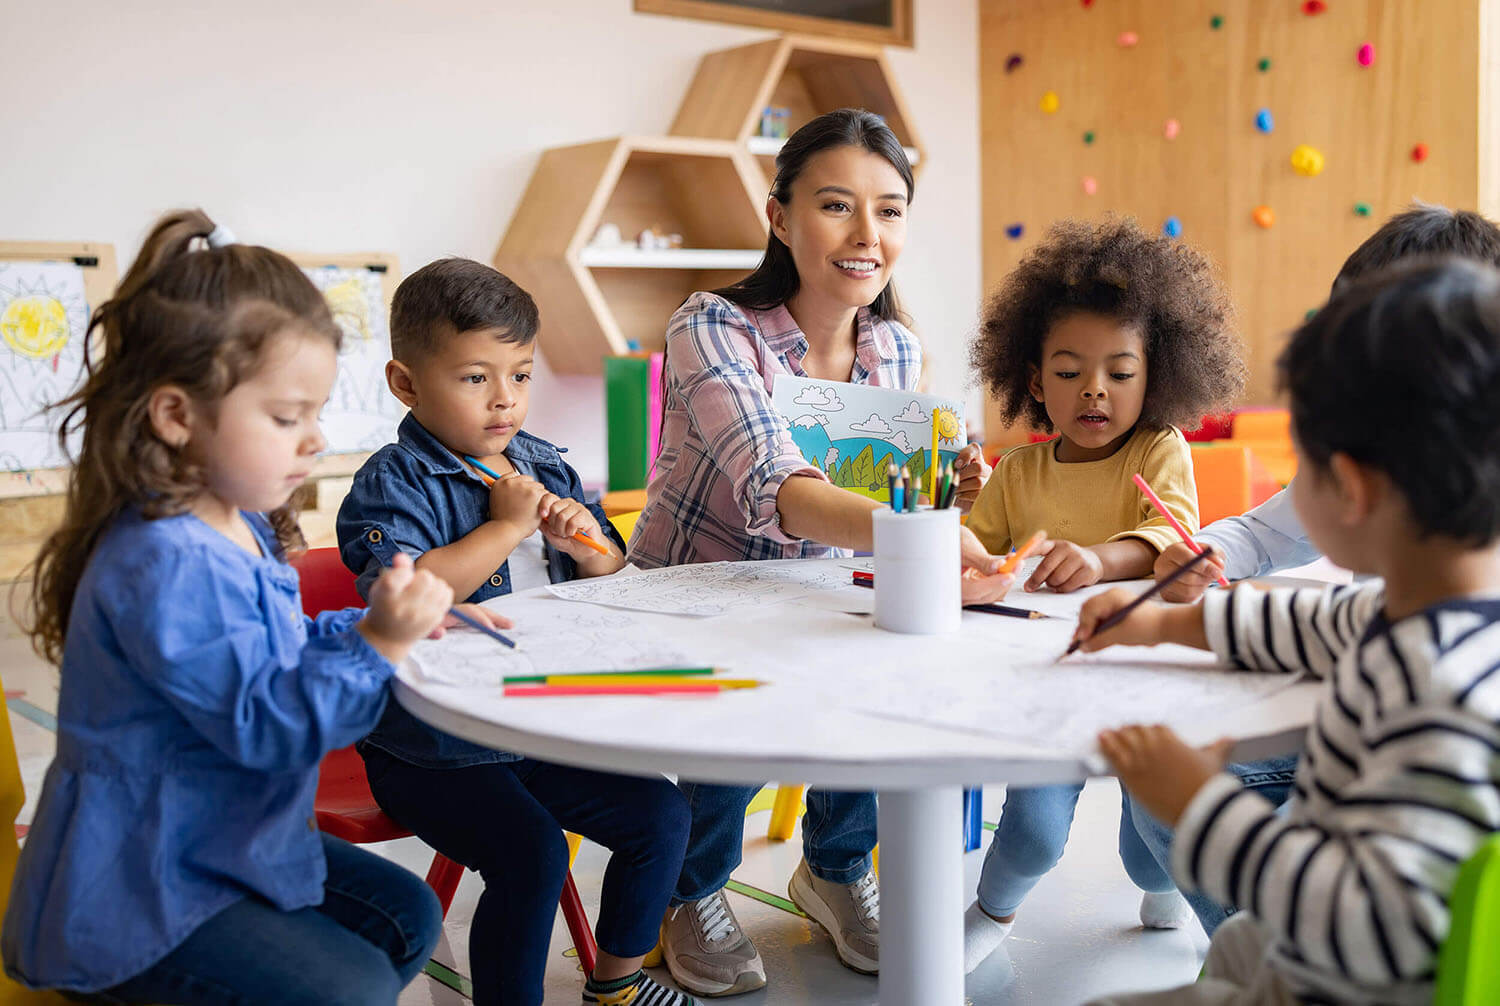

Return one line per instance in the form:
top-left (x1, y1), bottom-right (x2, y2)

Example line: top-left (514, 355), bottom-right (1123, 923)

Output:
top-left (771, 375), bottom-right (966, 502)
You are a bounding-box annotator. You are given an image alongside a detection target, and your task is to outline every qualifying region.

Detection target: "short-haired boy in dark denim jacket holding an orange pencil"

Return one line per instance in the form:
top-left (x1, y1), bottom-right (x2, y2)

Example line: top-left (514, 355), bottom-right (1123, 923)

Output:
top-left (338, 258), bottom-right (692, 1006)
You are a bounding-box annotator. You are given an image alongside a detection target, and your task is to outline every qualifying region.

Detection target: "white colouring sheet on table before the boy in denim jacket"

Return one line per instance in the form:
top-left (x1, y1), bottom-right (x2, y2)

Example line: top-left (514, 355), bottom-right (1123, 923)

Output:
top-left (411, 598), bottom-right (693, 688)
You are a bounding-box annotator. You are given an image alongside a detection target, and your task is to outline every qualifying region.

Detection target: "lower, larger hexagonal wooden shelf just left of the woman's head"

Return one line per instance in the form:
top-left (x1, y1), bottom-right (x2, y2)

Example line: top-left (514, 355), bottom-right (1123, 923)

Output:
top-left (495, 136), bottom-right (767, 373)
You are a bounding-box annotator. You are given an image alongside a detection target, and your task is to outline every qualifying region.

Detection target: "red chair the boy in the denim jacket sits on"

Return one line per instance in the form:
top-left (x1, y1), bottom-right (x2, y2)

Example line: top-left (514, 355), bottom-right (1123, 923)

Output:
top-left (293, 549), bottom-right (599, 975)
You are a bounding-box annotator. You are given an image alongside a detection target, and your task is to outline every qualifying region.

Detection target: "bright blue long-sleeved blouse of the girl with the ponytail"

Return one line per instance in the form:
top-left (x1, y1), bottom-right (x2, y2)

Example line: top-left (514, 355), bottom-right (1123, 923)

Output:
top-left (0, 510), bottom-right (395, 993)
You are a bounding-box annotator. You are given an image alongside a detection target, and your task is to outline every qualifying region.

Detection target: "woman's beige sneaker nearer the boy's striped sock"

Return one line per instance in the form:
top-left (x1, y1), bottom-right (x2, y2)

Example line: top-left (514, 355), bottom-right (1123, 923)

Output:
top-left (662, 891), bottom-right (765, 996)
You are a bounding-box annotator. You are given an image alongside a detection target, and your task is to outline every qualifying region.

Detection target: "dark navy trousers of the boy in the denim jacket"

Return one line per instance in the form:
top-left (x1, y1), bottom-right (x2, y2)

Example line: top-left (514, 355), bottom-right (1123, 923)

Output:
top-left (360, 745), bottom-right (687, 1006)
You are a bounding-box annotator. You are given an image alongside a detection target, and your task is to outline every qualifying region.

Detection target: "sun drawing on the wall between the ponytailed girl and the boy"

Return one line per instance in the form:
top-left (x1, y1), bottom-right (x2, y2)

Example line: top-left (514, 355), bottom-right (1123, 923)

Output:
top-left (302, 265), bottom-right (407, 453)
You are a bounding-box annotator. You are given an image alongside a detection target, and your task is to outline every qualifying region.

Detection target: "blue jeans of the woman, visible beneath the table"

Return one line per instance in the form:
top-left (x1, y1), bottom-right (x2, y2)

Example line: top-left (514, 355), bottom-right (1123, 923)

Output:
top-left (672, 781), bottom-right (876, 904)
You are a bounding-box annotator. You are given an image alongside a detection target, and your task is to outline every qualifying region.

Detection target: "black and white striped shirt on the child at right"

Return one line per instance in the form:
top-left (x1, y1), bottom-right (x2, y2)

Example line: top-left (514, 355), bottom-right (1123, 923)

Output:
top-left (1172, 582), bottom-right (1500, 1003)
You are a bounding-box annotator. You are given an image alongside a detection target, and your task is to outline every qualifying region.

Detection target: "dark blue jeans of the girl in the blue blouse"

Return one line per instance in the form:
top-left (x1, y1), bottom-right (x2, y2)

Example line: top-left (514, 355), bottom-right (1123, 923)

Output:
top-left (75, 835), bottom-right (443, 1006)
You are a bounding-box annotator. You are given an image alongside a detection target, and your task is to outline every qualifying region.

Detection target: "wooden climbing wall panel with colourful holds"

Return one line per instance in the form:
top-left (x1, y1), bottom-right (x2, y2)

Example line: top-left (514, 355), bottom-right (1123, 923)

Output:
top-left (978, 0), bottom-right (1500, 439)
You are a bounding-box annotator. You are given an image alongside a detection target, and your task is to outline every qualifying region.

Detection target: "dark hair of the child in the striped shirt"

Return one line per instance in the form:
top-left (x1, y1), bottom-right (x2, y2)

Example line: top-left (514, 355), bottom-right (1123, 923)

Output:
top-left (1278, 258), bottom-right (1500, 546)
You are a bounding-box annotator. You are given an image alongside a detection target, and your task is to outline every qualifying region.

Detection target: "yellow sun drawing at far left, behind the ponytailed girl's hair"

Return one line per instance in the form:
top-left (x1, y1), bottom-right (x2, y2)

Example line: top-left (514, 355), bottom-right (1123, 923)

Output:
top-left (0, 261), bottom-right (89, 471)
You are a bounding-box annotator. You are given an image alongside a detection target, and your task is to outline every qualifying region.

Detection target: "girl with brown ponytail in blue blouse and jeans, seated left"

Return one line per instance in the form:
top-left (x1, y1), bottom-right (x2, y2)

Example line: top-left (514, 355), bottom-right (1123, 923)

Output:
top-left (0, 211), bottom-right (494, 1006)
